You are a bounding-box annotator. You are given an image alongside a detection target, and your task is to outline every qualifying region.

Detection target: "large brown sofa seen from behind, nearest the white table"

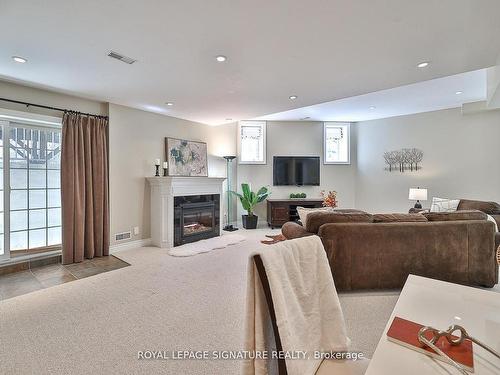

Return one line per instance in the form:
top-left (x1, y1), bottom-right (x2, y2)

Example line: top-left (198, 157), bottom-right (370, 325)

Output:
top-left (282, 201), bottom-right (500, 290)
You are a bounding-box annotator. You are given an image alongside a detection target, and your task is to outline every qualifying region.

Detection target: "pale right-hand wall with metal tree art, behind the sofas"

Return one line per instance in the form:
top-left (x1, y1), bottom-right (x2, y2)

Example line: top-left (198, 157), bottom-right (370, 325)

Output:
top-left (356, 108), bottom-right (500, 212)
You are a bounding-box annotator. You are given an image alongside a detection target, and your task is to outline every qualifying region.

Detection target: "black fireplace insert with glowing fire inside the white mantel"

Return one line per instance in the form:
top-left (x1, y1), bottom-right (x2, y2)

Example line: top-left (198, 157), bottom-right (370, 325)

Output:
top-left (174, 194), bottom-right (220, 246)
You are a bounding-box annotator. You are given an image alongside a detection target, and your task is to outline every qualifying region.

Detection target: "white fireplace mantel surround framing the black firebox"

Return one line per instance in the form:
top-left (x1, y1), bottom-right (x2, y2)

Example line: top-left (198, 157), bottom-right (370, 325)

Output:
top-left (147, 177), bottom-right (225, 248)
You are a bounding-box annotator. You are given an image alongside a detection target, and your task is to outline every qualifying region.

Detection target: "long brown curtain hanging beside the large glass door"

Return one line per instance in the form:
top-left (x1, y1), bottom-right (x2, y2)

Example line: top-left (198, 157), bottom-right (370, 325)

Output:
top-left (61, 112), bottom-right (109, 264)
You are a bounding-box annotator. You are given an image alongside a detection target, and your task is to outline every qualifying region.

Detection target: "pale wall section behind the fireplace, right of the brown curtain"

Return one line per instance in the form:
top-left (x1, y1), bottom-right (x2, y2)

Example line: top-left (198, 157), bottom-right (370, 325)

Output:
top-left (109, 104), bottom-right (236, 243)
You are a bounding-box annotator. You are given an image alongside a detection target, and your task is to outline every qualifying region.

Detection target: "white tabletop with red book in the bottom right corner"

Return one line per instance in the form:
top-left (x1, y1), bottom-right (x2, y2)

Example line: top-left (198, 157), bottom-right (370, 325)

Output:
top-left (366, 275), bottom-right (500, 375)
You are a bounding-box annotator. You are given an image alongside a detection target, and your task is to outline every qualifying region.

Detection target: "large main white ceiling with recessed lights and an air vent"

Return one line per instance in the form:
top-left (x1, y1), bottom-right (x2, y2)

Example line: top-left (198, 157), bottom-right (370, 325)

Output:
top-left (0, 0), bottom-right (500, 124)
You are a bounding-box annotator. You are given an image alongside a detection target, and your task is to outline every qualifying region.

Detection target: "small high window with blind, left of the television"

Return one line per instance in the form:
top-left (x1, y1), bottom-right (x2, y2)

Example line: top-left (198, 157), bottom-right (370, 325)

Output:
top-left (238, 121), bottom-right (266, 164)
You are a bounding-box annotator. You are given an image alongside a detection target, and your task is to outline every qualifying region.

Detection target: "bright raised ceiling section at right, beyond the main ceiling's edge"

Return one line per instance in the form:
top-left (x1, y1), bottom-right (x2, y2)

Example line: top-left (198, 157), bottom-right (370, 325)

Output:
top-left (256, 69), bottom-right (487, 122)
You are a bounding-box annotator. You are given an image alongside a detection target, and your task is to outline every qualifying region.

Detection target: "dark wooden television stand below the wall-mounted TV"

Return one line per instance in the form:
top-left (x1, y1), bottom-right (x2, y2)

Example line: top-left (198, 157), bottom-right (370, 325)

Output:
top-left (267, 198), bottom-right (323, 229)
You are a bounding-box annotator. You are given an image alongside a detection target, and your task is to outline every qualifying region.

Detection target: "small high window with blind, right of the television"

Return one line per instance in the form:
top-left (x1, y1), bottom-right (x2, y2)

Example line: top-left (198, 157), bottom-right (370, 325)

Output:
top-left (323, 122), bottom-right (350, 164)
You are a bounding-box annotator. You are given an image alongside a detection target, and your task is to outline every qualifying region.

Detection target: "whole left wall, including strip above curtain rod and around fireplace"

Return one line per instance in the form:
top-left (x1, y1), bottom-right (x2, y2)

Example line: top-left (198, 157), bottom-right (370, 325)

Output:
top-left (0, 81), bottom-right (236, 244)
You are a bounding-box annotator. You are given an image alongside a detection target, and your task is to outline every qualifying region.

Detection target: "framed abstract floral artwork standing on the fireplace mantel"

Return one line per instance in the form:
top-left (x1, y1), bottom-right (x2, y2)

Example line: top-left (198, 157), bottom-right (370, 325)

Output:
top-left (165, 137), bottom-right (208, 177)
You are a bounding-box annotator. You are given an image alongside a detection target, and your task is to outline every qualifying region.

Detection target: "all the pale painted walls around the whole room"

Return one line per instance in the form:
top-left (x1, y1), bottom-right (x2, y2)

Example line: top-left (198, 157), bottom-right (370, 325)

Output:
top-left (0, 81), bottom-right (500, 244)
